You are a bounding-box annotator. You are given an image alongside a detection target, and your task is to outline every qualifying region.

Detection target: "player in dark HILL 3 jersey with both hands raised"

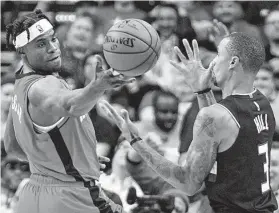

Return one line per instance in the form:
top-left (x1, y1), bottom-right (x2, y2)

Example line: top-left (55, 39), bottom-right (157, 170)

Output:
top-left (102, 23), bottom-right (278, 213)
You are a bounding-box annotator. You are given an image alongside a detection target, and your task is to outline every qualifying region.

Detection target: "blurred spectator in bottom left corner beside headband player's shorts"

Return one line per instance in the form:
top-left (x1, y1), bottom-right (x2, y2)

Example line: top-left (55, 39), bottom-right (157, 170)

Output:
top-left (1, 155), bottom-right (31, 212)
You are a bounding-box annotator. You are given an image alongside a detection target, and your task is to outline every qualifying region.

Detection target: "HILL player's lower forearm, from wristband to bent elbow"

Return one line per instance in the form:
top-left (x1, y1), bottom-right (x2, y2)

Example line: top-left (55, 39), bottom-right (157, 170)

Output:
top-left (132, 140), bottom-right (199, 195)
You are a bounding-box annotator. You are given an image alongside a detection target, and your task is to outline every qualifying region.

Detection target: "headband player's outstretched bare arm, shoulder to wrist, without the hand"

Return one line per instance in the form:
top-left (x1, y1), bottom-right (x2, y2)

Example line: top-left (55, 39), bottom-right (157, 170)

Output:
top-left (28, 76), bottom-right (104, 117)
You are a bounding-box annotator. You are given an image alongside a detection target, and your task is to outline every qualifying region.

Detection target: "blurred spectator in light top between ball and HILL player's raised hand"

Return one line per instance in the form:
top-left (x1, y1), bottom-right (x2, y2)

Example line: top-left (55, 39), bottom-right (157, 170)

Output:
top-left (145, 3), bottom-right (196, 93)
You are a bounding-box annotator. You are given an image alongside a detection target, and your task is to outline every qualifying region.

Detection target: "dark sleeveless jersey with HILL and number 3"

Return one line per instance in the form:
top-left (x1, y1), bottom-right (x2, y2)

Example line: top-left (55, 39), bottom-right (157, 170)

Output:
top-left (206, 90), bottom-right (277, 213)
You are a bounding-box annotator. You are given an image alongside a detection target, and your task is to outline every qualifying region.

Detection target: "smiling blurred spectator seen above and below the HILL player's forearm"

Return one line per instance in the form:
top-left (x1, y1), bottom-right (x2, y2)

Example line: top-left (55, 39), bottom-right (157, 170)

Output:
top-left (124, 91), bottom-right (184, 194)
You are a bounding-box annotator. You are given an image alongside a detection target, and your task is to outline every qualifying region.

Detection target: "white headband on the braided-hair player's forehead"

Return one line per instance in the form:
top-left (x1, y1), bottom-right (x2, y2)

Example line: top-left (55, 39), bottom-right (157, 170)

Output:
top-left (13, 19), bottom-right (53, 48)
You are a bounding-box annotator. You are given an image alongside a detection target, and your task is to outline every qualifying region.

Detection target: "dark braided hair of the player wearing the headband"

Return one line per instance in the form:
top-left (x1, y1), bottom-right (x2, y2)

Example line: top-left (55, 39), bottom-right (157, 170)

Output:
top-left (6, 9), bottom-right (50, 48)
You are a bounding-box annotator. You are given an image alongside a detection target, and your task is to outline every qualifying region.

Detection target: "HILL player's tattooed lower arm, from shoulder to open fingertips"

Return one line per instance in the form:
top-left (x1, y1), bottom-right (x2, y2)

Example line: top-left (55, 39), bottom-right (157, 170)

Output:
top-left (99, 102), bottom-right (239, 195)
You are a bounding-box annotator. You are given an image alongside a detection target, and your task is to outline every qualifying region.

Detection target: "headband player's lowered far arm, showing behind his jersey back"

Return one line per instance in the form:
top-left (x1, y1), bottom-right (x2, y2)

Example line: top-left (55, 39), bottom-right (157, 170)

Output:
top-left (4, 107), bottom-right (28, 161)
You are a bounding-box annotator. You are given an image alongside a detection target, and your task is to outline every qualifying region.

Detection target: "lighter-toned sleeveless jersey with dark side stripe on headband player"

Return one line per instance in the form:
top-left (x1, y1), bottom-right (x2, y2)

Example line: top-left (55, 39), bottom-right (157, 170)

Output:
top-left (12, 68), bottom-right (100, 181)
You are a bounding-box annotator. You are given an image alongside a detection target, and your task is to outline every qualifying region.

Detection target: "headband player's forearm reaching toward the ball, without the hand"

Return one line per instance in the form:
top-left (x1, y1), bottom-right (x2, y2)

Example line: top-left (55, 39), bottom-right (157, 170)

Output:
top-left (64, 81), bottom-right (106, 116)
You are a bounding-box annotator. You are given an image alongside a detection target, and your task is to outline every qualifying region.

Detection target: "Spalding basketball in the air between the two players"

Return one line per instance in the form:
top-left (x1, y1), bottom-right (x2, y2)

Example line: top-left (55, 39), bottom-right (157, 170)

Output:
top-left (103, 19), bottom-right (161, 77)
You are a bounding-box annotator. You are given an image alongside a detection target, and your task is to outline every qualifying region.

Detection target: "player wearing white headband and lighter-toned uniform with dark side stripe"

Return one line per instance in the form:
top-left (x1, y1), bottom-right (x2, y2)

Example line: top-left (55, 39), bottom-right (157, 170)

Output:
top-left (5, 10), bottom-right (136, 213)
